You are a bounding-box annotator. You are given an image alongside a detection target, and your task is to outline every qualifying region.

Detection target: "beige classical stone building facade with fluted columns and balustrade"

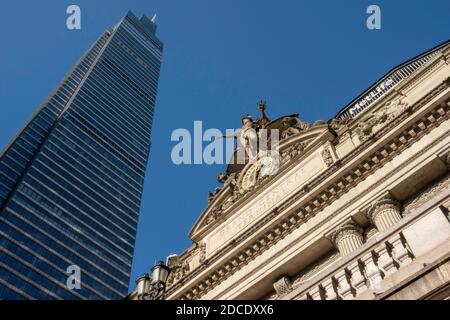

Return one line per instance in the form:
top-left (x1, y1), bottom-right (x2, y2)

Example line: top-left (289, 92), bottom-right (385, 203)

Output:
top-left (129, 42), bottom-right (450, 300)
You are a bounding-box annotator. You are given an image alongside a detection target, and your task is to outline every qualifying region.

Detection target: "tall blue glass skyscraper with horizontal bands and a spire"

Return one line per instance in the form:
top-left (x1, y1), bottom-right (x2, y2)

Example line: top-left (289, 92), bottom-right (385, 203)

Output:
top-left (0, 12), bottom-right (163, 299)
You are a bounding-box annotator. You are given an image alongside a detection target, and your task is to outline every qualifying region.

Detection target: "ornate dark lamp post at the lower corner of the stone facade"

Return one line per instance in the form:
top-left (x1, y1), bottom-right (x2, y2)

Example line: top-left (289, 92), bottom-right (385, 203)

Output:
top-left (136, 261), bottom-right (170, 300)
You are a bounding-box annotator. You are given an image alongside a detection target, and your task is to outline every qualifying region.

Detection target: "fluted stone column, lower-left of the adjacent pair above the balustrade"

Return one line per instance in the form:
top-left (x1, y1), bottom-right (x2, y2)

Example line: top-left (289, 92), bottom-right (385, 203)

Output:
top-left (331, 222), bottom-right (363, 256)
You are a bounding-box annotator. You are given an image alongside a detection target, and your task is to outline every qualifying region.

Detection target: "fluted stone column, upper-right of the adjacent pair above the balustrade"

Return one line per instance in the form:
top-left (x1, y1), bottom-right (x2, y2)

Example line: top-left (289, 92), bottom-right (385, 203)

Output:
top-left (367, 195), bottom-right (402, 232)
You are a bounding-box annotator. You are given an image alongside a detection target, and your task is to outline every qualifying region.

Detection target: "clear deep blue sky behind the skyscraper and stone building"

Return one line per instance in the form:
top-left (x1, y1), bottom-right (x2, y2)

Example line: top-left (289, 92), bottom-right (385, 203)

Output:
top-left (0, 0), bottom-right (450, 286)
